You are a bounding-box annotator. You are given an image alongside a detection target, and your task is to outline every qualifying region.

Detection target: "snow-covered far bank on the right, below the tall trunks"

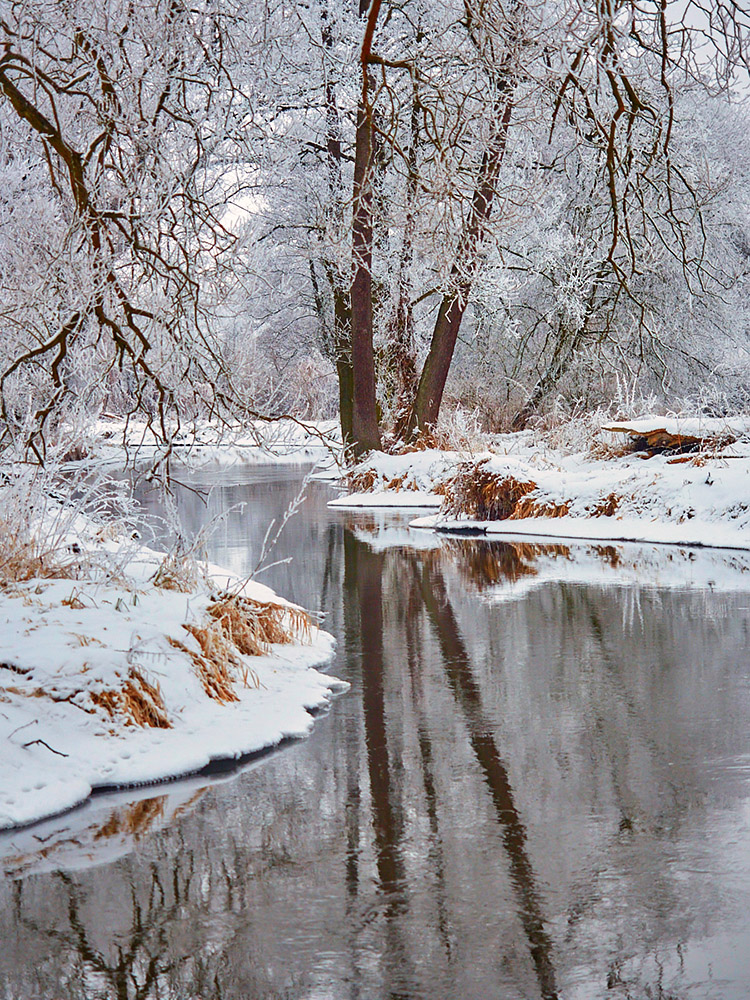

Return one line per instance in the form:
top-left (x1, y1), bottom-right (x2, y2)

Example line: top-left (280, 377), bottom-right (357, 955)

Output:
top-left (331, 417), bottom-right (750, 549)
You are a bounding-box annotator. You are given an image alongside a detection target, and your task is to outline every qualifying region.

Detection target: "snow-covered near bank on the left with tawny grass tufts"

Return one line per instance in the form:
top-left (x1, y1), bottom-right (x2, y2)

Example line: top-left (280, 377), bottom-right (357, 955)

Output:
top-left (0, 512), bottom-right (346, 829)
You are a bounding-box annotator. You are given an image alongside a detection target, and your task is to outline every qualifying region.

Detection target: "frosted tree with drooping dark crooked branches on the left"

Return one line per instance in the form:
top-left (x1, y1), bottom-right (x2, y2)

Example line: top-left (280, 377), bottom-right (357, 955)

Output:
top-left (0, 0), bottom-right (256, 458)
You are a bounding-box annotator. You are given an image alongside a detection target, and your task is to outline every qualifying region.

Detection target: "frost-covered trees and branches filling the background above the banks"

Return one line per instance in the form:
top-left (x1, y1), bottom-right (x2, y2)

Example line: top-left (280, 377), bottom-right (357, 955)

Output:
top-left (0, 0), bottom-right (750, 457)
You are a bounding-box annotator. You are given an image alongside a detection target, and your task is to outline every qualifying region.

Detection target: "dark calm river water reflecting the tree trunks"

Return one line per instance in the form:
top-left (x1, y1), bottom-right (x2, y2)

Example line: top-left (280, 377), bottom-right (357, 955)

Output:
top-left (0, 469), bottom-right (750, 1000)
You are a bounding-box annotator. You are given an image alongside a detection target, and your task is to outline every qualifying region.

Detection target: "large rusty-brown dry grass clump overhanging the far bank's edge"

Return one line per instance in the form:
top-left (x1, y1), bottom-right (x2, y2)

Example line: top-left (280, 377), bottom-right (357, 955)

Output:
top-left (441, 462), bottom-right (537, 521)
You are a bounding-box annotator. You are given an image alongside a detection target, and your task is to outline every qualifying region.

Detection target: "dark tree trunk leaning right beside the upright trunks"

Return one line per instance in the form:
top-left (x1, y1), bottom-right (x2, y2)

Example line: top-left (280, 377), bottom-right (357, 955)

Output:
top-left (407, 79), bottom-right (515, 435)
